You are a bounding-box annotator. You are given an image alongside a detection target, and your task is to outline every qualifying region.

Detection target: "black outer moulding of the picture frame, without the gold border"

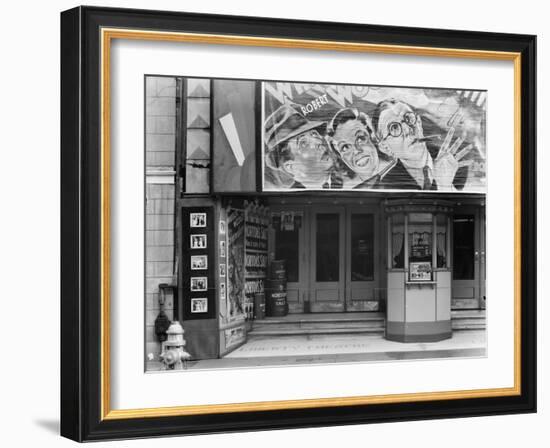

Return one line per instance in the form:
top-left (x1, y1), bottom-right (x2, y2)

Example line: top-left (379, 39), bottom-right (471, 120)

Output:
top-left (61, 7), bottom-right (537, 441)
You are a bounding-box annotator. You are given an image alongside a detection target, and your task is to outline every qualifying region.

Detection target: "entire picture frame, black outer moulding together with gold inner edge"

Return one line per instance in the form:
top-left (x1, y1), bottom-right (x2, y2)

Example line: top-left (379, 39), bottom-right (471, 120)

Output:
top-left (61, 7), bottom-right (537, 441)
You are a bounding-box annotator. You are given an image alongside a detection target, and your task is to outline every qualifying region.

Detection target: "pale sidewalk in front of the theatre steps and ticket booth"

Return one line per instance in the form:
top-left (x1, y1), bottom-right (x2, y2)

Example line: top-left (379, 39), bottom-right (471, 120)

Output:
top-left (147, 330), bottom-right (486, 371)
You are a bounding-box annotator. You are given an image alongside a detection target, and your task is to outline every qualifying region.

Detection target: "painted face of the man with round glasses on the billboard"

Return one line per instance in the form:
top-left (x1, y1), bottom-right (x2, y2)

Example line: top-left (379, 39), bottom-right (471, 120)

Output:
top-left (377, 103), bottom-right (428, 166)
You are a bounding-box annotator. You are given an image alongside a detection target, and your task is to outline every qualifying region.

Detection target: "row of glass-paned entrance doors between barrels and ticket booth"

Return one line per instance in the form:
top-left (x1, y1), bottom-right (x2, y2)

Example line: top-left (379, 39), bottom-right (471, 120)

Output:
top-left (273, 206), bottom-right (379, 313)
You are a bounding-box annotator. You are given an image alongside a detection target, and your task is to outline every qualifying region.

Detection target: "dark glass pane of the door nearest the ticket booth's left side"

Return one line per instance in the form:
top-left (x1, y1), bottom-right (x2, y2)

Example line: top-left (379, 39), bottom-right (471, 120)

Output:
top-left (351, 214), bottom-right (374, 281)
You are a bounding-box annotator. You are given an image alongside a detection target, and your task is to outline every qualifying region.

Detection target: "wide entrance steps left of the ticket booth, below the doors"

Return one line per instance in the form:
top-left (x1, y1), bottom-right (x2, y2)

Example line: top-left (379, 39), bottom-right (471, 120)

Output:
top-left (248, 313), bottom-right (386, 337)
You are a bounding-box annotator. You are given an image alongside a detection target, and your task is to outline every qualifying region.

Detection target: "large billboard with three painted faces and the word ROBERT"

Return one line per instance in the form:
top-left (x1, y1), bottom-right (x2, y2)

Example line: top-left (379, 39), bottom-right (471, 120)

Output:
top-left (262, 82), bottom-right (487, 193)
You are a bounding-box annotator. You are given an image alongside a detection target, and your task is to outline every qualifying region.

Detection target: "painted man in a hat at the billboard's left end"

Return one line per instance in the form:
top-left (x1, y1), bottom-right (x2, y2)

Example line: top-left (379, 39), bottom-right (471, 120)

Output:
top-left (264, 103), bottom-right (334, 189)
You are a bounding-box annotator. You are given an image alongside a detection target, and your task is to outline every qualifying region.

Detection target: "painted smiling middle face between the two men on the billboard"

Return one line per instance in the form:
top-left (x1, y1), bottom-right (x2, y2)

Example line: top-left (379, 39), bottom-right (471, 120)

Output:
top-left (333, 120), bottom-right (378, 178)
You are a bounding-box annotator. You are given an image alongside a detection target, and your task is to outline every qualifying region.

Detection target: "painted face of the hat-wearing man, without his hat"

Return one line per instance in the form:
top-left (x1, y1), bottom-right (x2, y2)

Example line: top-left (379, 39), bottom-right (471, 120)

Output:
top-left (283, 129), bottom-right (333, 188)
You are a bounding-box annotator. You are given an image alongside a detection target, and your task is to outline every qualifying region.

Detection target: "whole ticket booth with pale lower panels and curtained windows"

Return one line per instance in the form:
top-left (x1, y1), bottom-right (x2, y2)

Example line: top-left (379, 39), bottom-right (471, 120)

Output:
top-left (385, 200), bottom-right (453, 342)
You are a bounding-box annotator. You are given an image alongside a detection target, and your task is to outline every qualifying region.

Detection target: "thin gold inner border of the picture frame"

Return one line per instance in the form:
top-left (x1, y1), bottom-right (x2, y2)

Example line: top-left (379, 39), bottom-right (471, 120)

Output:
top-left (100, 28), bottom-right (521, 420)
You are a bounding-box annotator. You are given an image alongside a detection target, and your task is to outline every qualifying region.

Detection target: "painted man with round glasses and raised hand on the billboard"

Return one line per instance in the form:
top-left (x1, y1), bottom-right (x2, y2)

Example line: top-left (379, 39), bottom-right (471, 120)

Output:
top-left (372, 99), bottom-right (471, 191)
